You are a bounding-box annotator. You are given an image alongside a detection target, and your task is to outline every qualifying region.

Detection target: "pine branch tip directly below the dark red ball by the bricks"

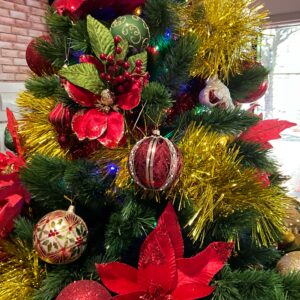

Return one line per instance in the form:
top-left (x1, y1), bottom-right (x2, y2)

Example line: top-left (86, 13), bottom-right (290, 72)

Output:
top-left (25, 75), bottom-right (60, 98)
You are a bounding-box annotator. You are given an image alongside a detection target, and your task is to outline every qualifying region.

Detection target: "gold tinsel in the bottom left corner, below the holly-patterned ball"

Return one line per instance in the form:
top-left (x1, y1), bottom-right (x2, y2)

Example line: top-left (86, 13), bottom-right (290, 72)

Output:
top-left (0, 239), bottom-right (46, 300)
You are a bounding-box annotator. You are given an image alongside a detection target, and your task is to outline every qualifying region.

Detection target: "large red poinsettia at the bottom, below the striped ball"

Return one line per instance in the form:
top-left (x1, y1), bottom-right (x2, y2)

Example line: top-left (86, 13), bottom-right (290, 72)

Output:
top-left (96, 203), bottom-right (233, 300)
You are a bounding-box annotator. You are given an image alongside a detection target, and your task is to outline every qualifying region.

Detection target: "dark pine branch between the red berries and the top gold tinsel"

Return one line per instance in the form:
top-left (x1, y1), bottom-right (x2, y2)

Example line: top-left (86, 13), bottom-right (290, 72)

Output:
top-left (151, 34), bottom-right (199, 94)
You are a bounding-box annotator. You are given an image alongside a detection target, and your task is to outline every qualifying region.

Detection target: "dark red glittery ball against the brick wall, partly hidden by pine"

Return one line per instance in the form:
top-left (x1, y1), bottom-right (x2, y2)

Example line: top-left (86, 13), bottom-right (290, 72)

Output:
top-left (26, 35), bottom-right (54, 76)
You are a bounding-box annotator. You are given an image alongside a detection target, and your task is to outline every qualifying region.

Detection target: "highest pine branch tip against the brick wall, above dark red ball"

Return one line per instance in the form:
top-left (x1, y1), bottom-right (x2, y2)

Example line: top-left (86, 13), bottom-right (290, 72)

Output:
top-left (45, 8), bottom-right (72, 36)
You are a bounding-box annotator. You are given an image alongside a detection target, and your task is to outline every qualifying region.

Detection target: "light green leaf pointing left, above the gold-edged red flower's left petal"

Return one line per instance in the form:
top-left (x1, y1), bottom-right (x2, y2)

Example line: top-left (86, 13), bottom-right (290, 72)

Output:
top-left (59, 63), bottom-right (105, 94)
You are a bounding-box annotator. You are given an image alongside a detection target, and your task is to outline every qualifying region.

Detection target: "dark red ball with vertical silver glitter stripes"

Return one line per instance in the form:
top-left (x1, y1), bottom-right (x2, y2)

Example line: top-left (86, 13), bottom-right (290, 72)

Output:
top-left (128, 131), bottom-right (183, 191)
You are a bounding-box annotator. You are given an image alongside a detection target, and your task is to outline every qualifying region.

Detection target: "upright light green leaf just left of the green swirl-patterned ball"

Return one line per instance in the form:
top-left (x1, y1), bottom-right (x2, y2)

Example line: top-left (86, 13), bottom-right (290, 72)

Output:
top-left (87, 16), bottom-right (115, 57)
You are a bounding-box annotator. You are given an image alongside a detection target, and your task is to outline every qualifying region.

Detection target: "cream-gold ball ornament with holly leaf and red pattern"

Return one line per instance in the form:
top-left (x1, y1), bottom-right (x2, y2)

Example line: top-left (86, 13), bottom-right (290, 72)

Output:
top-left (33, 206), bottom-right (88, 264)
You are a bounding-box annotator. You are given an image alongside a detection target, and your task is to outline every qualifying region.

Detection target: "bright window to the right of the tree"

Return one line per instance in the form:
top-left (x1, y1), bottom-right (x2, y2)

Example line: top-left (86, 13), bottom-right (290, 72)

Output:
top-left (258, 25), bottom-right (300, 199)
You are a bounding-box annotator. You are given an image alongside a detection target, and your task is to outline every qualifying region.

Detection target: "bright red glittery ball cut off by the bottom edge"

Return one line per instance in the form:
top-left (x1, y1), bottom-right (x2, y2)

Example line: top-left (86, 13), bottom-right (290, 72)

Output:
top-left (56, 280), bottom-right (112, 300)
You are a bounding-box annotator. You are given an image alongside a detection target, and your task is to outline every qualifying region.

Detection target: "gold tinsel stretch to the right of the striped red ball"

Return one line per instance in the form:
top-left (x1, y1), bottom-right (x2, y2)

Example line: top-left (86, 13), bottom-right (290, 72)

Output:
top-left (167, 125), bottom-right (289, 246)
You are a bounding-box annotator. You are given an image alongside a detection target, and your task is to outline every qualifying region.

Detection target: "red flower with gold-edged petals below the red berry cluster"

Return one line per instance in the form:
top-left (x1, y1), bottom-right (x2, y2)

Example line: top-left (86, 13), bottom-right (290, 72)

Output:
top-left (65, 80), bottom-right (142, 148)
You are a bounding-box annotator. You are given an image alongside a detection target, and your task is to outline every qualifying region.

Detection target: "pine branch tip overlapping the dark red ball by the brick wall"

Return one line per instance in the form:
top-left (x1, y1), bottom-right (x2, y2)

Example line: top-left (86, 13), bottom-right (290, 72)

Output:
top-left (35, 35), bottom-right (70, 69)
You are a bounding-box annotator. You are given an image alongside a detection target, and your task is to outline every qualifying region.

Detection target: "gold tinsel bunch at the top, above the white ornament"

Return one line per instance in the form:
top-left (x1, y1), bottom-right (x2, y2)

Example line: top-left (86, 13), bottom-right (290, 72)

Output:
top-left (179, 0), bottom-right (268, 80)
